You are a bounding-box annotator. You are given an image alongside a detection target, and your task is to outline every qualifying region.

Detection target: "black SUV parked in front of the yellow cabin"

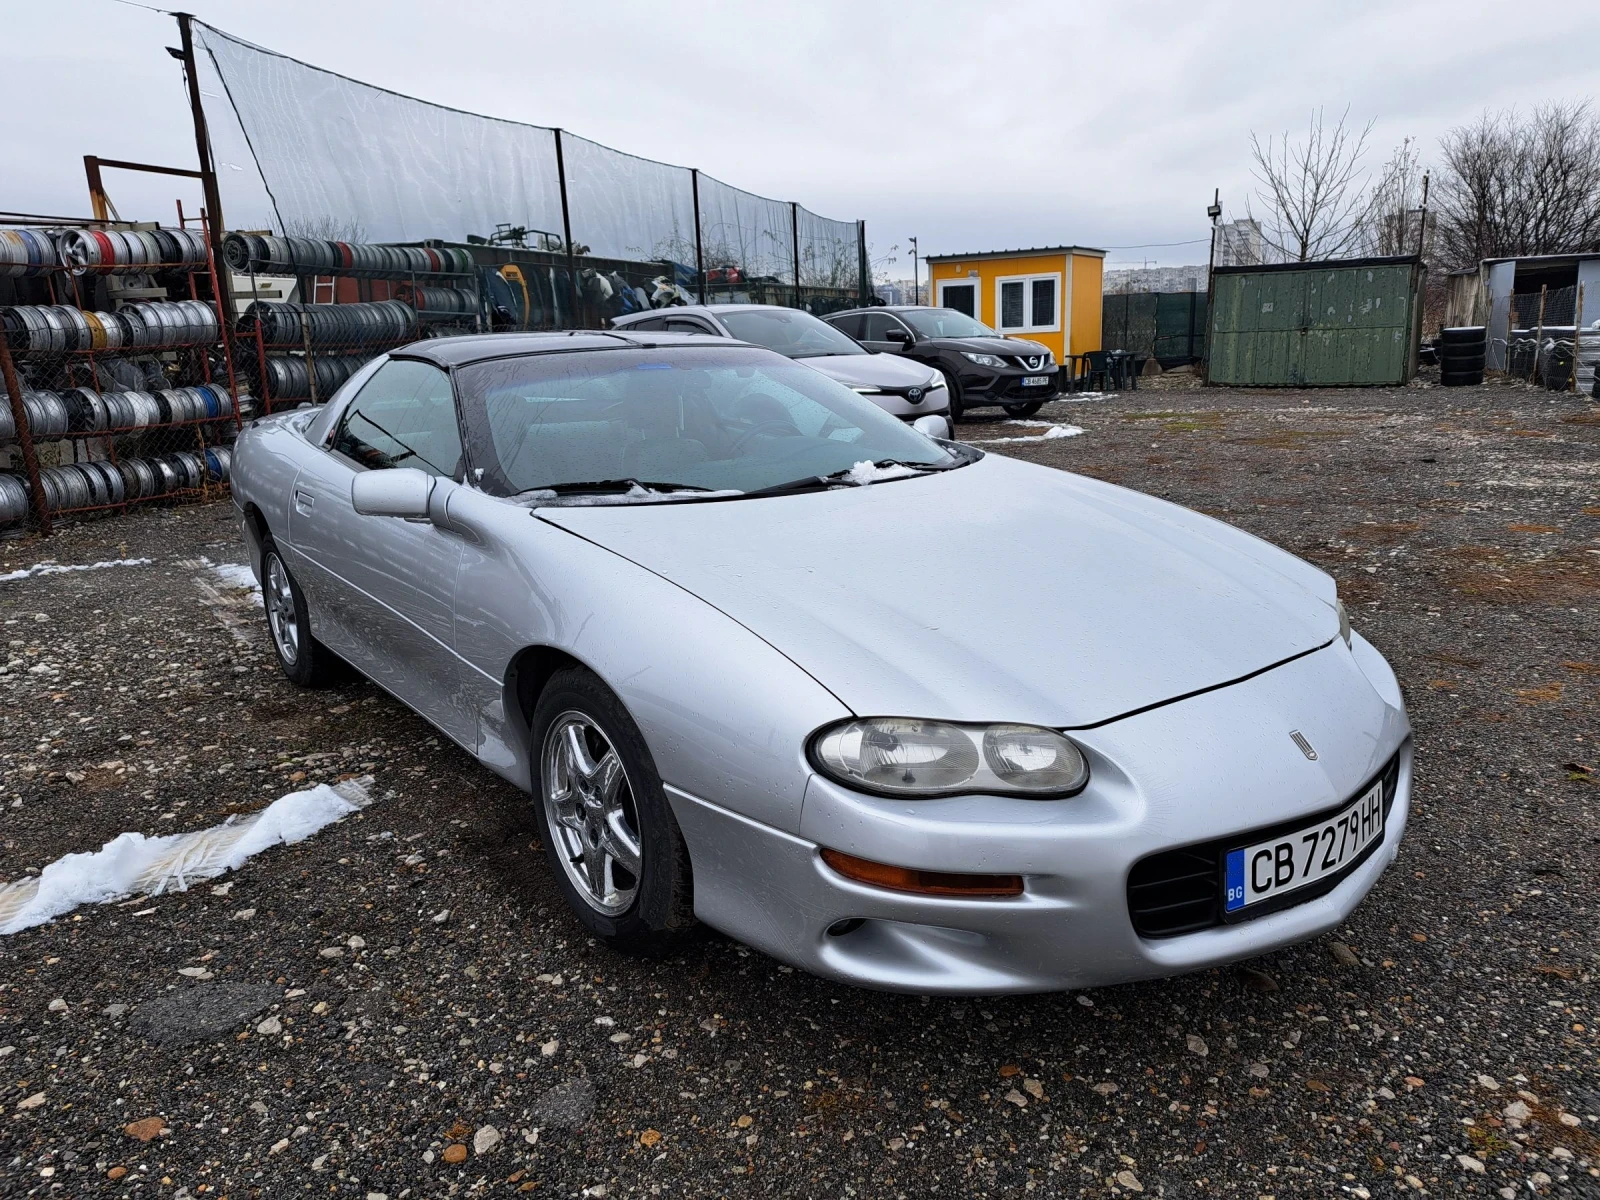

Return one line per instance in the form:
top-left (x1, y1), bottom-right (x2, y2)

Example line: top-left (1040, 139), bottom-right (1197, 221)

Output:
top-left (824, 304), bottom-right (1061, 421)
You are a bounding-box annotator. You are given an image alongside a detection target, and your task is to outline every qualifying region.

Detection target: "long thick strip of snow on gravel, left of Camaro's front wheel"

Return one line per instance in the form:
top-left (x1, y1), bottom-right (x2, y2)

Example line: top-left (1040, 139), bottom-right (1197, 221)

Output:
top-left (0, 776), bottom-right (371, 934)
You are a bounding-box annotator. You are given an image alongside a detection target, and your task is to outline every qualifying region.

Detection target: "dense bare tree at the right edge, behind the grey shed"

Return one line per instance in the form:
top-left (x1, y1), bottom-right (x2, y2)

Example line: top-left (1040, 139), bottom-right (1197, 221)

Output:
top-left (1435, 101), bottom-right (1600, 267)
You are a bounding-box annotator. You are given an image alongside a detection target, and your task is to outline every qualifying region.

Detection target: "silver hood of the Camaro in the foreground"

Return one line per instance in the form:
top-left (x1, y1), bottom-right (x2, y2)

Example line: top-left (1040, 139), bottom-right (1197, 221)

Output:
top-left (536, 454), bottom-right (1339, 728)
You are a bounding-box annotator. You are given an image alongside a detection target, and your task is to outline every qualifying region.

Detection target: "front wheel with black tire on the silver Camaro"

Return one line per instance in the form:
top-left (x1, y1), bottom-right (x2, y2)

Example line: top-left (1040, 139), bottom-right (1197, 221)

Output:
top-left (530, 667), bottom-right (694, 950)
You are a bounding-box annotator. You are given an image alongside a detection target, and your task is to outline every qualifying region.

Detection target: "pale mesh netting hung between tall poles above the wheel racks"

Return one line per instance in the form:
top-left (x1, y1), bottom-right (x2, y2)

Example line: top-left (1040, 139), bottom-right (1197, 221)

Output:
top-left (194, 21), bottom-right (859, 299)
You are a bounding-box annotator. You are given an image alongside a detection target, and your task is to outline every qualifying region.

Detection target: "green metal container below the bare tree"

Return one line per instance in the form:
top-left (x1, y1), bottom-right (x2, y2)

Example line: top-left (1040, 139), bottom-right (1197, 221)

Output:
top-left (1206, 256), bottom-right (1426, 387)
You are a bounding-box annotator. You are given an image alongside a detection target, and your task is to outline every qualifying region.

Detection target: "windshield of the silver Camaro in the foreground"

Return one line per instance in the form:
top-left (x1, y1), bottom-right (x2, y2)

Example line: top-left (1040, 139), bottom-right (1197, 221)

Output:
top-left (456, 346), bottom-right (971, 502)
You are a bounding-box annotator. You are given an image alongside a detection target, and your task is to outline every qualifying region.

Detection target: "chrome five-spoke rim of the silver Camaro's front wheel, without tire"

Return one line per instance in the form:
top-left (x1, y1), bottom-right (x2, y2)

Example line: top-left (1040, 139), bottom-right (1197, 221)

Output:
top-left (542, 709), bottom-right (643, 917)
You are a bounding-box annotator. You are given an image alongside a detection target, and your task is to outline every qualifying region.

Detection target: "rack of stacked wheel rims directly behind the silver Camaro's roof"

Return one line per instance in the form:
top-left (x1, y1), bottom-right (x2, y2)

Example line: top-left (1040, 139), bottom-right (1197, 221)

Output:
top-left (222, 234), bottom-right (486, 413)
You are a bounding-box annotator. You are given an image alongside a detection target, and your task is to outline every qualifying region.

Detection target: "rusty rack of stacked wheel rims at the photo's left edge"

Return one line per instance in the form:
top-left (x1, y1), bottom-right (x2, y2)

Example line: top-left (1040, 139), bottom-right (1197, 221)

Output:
top-left (0, 224), bottom-right (250, 534)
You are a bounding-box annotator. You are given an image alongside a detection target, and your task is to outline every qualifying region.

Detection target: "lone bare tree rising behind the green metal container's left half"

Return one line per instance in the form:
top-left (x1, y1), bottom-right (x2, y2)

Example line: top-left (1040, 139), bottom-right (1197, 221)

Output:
top-left (1250, 109), bottom-right (1373, 262)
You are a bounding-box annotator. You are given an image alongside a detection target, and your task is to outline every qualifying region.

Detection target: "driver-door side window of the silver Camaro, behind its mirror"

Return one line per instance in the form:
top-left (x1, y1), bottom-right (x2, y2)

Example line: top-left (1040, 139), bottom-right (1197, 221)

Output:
top-left (333, 358), bottom-right (461, 478)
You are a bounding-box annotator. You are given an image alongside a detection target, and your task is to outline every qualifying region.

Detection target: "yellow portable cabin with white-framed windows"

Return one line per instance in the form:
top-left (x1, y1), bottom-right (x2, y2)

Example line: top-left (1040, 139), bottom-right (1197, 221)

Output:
top-left (928, 246), bottom-right (1106, 362)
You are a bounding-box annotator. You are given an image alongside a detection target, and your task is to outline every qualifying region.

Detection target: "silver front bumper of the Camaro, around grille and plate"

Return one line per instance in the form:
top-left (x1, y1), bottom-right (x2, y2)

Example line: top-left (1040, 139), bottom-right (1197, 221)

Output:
top-left (667, 642), bottom-right (1411, 994)
